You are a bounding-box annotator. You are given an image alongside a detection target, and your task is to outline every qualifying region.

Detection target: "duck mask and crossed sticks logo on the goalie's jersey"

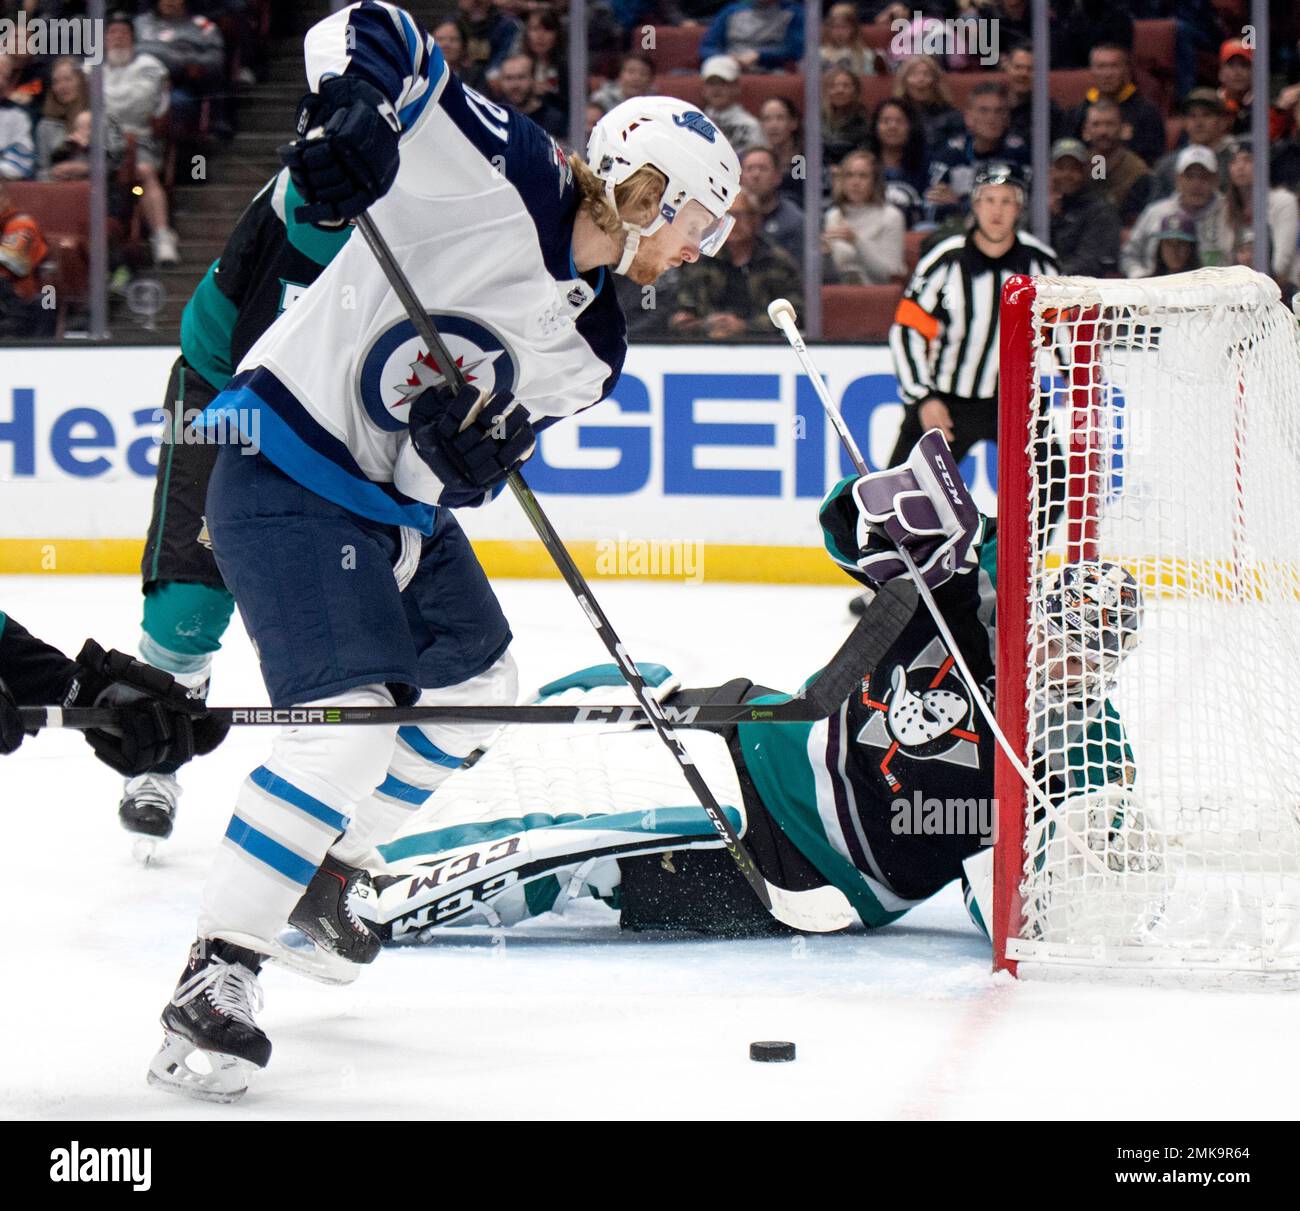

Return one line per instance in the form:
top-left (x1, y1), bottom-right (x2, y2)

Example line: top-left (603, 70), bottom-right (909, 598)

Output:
top-left (857, 639), bottom-right (979, 791)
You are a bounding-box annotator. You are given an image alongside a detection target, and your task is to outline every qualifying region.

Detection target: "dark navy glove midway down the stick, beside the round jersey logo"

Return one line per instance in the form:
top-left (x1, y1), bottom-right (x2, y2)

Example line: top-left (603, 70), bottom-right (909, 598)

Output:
top-left (410, 383), bottom-right (537, 508)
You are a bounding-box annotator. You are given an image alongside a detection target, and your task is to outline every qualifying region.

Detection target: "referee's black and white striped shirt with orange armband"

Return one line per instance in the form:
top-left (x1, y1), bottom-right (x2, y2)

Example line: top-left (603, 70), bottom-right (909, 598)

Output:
top-left (889, 231), bottom-right (1060, 404)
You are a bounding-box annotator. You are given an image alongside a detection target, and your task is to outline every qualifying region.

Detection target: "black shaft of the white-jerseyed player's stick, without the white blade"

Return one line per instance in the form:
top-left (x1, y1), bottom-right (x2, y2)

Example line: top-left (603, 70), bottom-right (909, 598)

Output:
top-left (356, 213), bottom-right (785, 928)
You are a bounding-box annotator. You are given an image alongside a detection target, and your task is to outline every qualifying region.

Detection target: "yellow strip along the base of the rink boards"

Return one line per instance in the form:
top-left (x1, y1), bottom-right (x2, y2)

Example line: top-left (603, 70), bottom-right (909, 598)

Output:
top-left (0, 538), bottom-right (853, 587)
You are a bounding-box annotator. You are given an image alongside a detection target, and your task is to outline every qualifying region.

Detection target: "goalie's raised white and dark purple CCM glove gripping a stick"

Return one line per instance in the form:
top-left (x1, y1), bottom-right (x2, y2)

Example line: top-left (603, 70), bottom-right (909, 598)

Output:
top-left (853, 429), bottom-right (983, 589)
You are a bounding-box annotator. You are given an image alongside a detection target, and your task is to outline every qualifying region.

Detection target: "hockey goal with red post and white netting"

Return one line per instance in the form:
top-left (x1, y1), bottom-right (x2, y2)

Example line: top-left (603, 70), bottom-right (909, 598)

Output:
top-left (993, 268), bottom-right (1300, 988)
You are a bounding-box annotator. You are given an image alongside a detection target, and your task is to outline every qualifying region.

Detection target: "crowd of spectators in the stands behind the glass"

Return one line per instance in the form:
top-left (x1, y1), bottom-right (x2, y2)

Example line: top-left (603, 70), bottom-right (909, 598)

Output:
top-left (0, 0), bottom-right (1300, 339)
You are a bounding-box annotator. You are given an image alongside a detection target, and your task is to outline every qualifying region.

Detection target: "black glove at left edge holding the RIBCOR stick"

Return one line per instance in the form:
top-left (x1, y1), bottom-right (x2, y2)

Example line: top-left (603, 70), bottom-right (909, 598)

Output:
top-left (64, 639), bottom-right (230, 778)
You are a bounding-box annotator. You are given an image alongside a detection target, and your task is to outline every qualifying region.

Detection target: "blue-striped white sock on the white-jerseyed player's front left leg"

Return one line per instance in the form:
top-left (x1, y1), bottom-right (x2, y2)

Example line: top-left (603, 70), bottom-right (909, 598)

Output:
top-left (199, 686), bottom-right (397, 945)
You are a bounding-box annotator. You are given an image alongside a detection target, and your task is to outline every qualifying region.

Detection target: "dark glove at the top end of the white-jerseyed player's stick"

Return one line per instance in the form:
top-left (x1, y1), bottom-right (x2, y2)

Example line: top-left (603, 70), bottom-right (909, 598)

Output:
top-left (280, 75), bottom-right (400, 223)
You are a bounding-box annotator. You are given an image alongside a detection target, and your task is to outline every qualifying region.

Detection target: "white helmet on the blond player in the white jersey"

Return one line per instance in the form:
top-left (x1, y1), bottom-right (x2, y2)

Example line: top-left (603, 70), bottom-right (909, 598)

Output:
top-left (586, 96), bottom-right (740, 273)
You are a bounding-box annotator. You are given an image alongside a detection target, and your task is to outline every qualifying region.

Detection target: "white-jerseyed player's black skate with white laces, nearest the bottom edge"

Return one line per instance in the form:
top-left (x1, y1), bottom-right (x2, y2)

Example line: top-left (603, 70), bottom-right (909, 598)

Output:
top-left (148, 938), bottom-right (270, 1102)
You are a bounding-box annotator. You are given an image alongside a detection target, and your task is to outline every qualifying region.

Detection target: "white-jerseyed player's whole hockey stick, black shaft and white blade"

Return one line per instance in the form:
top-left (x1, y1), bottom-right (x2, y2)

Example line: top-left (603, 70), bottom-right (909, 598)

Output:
top-left (343, 213), bottom-right (858, 933)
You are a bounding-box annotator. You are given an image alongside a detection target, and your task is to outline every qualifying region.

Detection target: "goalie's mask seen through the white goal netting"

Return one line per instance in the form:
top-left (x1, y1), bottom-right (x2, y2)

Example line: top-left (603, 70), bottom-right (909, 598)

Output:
top-left (1034, 561), bottom-right (1143, 702)
